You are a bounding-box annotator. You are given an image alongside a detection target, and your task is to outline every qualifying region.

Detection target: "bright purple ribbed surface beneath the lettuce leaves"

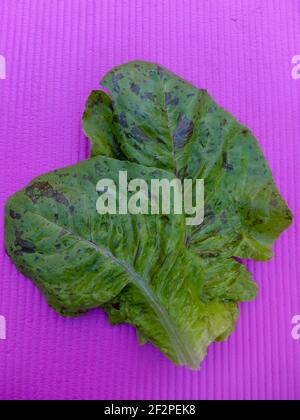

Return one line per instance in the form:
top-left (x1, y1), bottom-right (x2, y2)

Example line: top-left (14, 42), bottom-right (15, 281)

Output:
top-left (0, 0), bottom-right (300, 399)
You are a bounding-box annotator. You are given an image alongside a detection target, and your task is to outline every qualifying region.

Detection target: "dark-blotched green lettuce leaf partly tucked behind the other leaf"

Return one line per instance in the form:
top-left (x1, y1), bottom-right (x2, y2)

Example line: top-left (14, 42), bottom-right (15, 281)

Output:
top-left (83, 62), bottom-right (292, 261)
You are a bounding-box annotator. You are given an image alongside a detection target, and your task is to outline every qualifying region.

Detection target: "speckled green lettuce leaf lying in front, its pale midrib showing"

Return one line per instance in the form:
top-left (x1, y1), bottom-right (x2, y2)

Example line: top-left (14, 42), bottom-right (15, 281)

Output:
top-left (5, 157), bottom-right (248, 369)
